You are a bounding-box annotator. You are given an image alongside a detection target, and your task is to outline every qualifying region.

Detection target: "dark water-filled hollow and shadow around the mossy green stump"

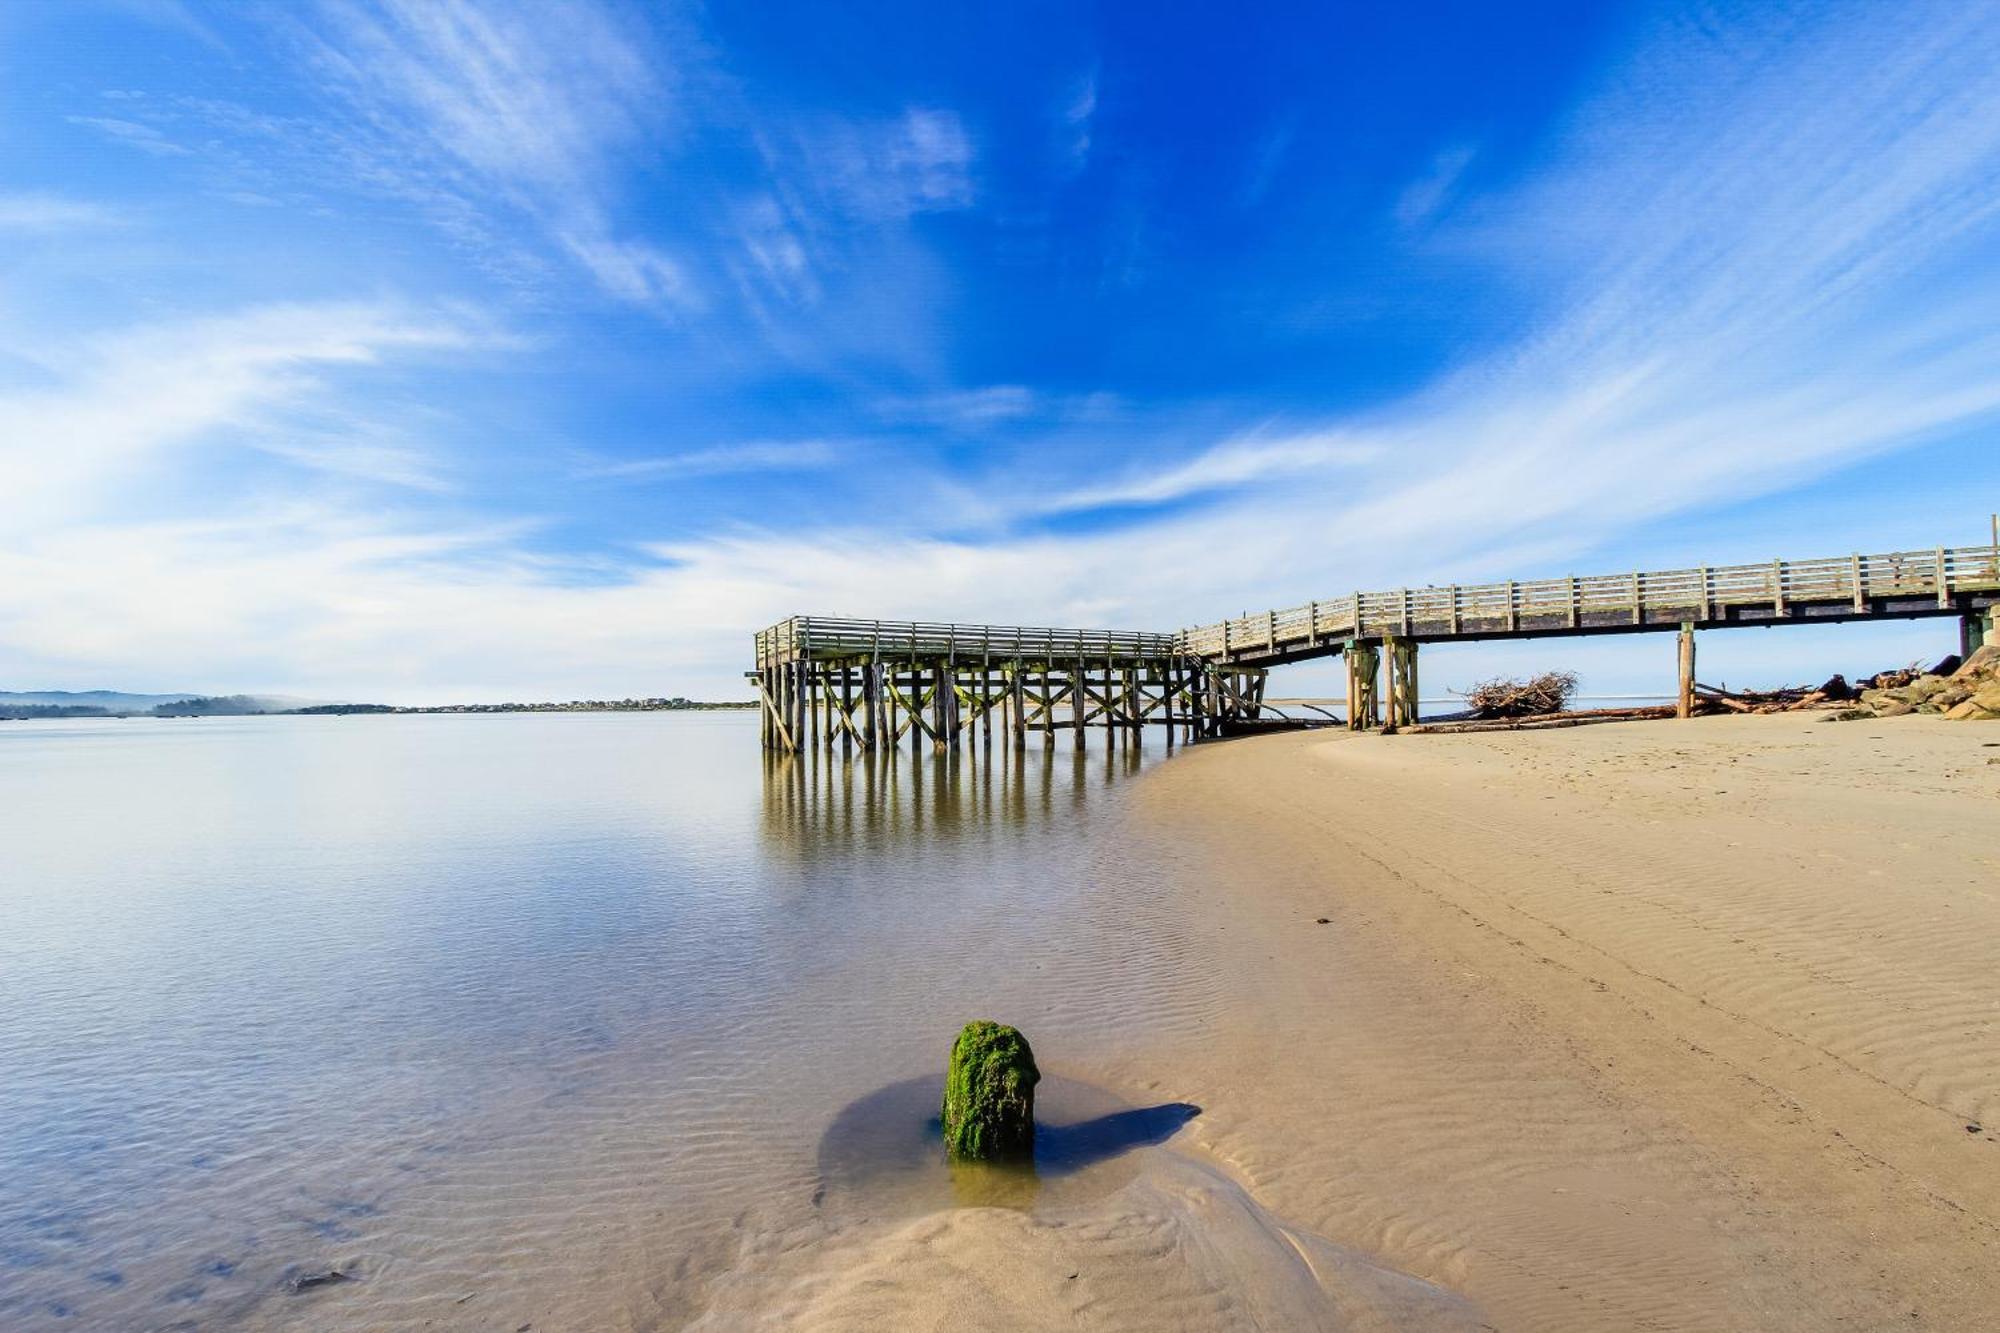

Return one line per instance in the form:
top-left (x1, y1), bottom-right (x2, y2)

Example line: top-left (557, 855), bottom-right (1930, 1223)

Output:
top-left (816, 1077), bottom-right (1202, 1215)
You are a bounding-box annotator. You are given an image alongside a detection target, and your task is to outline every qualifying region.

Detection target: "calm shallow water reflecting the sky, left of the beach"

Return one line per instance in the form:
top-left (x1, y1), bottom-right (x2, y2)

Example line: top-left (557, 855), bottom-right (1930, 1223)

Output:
top-left (0, 715), bottom-right (1202, 1329)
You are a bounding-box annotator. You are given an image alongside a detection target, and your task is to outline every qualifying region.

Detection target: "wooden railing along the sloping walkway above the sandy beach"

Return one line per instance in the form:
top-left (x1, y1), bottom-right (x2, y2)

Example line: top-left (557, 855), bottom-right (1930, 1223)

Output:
top-left (1178, 544), bottom-right (2000, 660)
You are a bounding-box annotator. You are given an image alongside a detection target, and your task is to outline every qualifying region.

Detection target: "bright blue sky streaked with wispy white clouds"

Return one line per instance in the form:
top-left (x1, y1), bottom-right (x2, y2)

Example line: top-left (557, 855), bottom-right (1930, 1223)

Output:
top-left (0, 0), bottom-right (2000, 703)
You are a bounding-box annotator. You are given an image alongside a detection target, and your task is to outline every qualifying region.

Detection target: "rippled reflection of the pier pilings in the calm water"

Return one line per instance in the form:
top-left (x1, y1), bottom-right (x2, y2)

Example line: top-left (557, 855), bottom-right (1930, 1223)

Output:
top-left (764, 739), bottom-right (1168, 845)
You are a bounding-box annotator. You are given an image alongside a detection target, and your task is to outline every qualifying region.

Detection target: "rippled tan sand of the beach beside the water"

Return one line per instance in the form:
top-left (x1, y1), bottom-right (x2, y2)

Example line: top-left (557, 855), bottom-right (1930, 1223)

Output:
top-left (710, 715), bottom-right (2000, 1329)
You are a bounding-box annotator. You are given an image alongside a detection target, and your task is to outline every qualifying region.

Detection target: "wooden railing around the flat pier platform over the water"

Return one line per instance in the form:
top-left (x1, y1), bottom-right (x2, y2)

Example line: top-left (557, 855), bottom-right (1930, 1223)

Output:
top-left (756, 616), bottom-right (1180, 671)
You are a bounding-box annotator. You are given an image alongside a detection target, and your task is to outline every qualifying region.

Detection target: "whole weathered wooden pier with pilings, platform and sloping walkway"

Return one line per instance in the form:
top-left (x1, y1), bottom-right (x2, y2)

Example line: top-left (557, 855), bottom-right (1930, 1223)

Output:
top-left (750, 540), bottom-right (2000, 751)
